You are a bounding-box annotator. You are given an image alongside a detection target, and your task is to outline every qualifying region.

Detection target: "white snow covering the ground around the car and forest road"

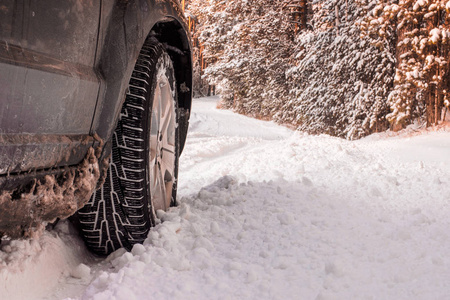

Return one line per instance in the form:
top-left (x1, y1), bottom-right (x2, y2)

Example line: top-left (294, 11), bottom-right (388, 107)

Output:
top-left (0, 98), bottom-right (450, 300)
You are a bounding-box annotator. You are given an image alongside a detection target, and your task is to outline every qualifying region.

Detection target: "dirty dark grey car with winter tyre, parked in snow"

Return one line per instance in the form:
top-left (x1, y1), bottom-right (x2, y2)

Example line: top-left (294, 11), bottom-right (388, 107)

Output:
top-left (0, 0), bottom-right (192, 255)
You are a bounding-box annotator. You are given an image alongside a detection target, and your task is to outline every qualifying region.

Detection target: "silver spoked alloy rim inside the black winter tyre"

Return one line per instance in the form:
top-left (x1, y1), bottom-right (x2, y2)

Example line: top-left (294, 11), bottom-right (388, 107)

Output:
top-left (149, 75), bottom-right (176, 211)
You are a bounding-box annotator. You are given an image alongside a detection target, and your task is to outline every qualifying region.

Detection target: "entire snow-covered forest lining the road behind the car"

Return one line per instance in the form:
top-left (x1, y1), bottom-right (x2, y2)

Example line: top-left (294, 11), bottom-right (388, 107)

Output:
top-left (185, 0), bottom-right (450, 139)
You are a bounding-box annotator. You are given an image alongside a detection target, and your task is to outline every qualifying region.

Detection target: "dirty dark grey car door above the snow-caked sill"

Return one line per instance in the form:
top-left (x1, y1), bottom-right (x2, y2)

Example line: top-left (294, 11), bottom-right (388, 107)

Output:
top-left (0, 0), bottom-right (101, 175)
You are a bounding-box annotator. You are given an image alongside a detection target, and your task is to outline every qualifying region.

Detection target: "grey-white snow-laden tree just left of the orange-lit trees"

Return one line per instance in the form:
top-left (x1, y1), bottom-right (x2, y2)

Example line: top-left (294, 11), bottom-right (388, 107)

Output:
top-left (284, 0), bottom-right (394, 139)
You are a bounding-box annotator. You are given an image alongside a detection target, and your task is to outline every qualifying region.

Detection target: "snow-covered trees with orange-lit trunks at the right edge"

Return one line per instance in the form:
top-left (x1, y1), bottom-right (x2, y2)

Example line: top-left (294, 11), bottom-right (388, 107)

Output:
top-left (361, 0), bottom-right (450, 128)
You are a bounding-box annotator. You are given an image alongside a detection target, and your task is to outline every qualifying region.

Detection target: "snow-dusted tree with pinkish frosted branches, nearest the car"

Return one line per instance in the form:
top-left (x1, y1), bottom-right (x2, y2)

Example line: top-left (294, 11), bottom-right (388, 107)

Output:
top-left (189, 0), bottom-right (293, 118)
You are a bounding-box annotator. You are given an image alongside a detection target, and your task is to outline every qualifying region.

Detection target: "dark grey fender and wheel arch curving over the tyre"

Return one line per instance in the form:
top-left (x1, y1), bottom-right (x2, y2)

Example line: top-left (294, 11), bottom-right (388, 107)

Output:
top-left (91, 0), bottom-right (192, 162)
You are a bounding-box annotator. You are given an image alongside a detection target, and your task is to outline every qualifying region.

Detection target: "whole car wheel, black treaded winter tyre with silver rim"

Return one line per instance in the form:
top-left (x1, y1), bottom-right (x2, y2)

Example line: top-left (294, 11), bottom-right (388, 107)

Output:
top-left (78, 38), bottom-right (180, 255)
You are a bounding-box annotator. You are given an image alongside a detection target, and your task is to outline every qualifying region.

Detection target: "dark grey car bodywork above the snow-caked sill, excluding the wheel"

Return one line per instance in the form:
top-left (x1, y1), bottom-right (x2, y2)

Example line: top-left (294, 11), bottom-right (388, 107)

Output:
top-left (0, 0), bottom-right (192, 233)
